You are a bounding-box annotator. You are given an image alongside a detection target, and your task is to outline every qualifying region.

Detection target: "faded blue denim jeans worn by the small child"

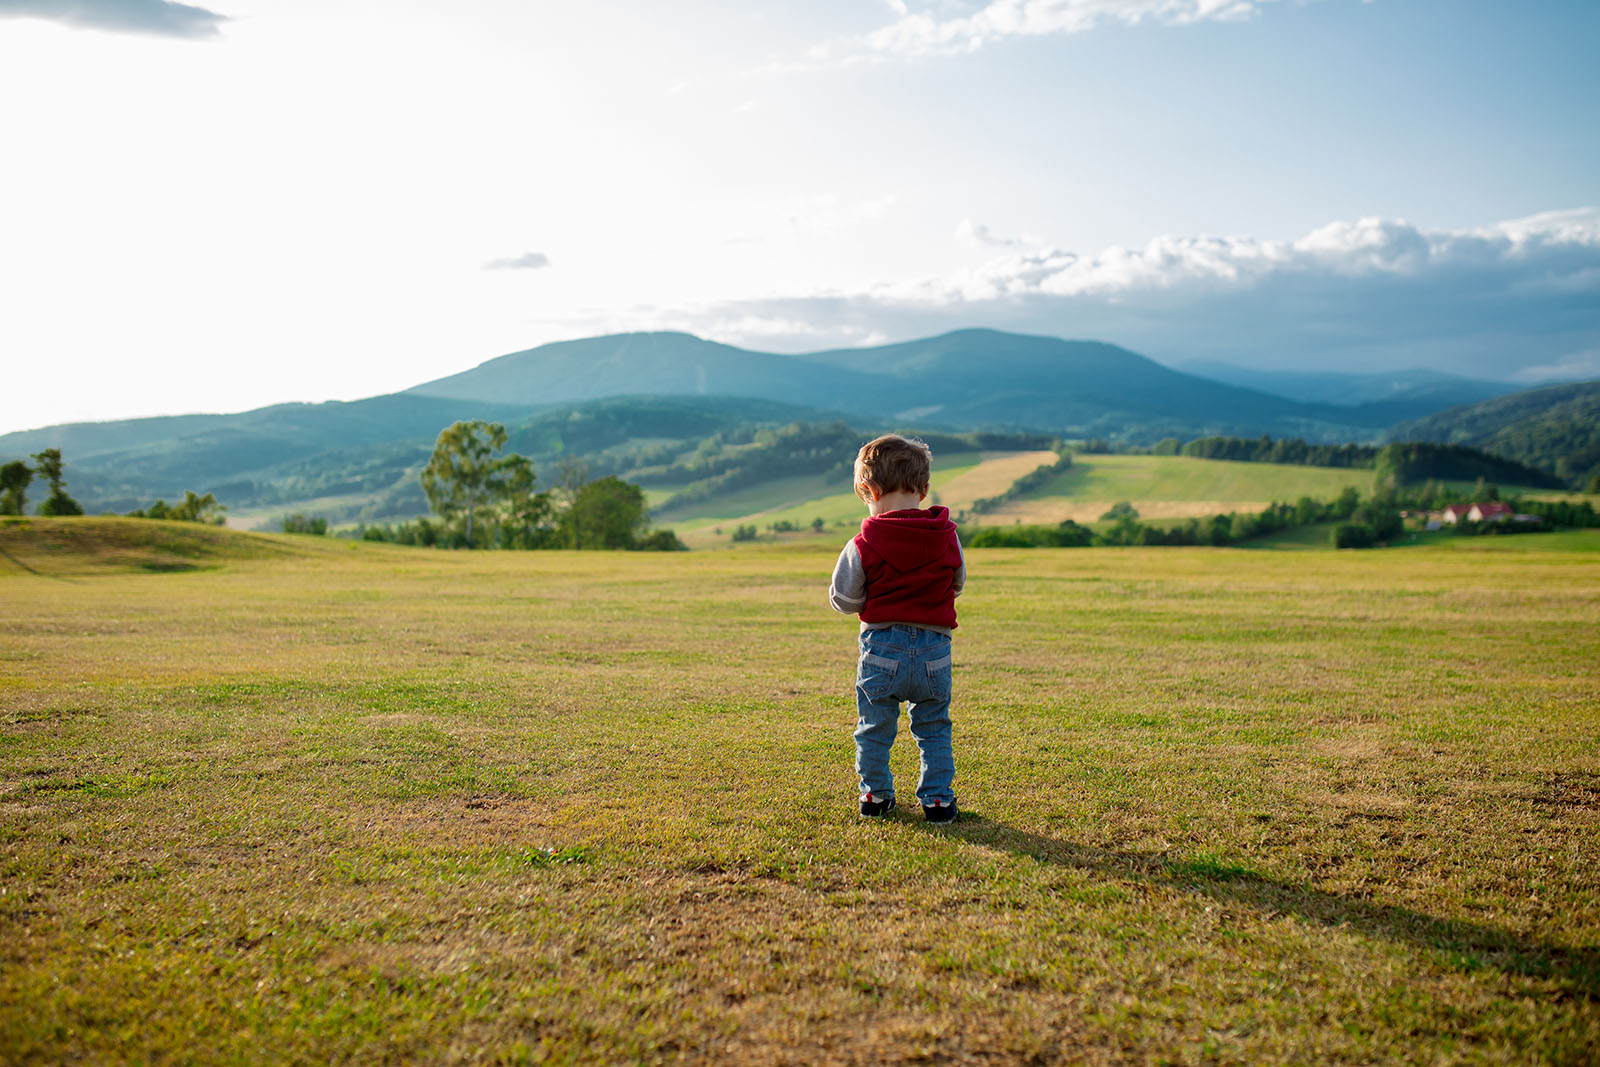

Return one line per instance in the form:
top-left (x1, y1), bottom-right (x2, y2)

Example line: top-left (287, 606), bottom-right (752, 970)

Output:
top-left (856, 625), bottom-right (955, 805)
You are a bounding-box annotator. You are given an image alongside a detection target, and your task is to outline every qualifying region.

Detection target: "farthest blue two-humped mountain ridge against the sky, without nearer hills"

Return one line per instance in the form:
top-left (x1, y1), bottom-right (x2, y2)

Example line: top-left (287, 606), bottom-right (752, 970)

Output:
top-left (408, 330), bottom-right (1414, 440)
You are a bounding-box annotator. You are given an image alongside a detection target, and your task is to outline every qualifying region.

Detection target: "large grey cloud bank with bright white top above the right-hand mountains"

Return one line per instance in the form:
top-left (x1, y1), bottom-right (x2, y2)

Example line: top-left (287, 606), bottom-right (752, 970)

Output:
top-left (585, 208), bottom-right (1600, 381)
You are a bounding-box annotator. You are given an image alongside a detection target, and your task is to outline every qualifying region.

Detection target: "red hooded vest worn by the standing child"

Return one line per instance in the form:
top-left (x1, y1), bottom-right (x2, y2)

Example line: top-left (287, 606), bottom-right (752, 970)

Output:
top-left (854, 506), bottom-right (962, 630)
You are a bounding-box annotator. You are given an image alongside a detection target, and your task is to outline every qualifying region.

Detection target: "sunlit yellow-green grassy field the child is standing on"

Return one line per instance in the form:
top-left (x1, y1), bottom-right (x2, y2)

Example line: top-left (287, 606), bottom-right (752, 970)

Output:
top-left (0, 520), bottom-right (1600, 1064)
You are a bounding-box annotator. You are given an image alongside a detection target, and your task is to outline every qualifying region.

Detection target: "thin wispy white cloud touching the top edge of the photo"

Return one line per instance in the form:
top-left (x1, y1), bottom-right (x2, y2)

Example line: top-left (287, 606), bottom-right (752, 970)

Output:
top-left (800, 0), bottom-right (1277, 66)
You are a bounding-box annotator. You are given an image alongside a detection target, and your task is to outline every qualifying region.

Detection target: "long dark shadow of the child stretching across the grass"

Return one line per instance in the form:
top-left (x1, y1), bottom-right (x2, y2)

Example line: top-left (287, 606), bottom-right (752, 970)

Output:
top-left (912, 811), bottom-right (1600, 1000)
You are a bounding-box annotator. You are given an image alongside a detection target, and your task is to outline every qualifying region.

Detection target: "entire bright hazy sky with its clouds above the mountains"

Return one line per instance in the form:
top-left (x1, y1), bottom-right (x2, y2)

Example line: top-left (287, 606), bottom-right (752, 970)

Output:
top-left (0, 0), bottom-right (1600, 430)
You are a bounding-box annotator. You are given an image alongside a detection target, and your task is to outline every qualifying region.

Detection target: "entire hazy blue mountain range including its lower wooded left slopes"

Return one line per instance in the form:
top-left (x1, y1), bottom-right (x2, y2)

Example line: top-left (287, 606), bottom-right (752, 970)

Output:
top-left (0, 330), bottom-right (1586, 514)
